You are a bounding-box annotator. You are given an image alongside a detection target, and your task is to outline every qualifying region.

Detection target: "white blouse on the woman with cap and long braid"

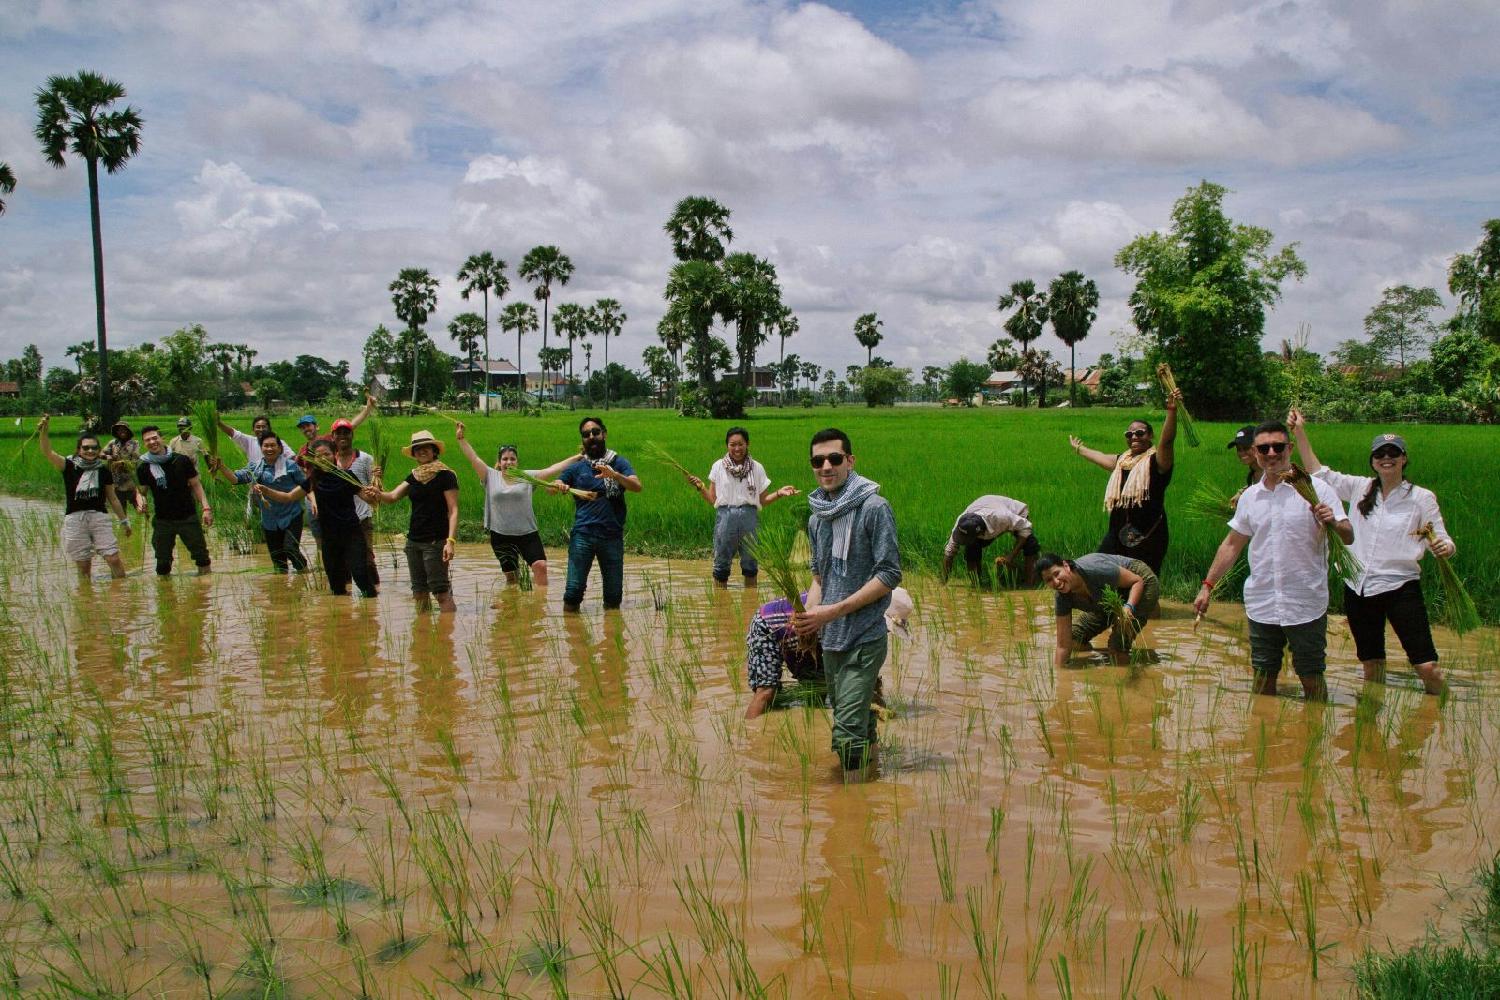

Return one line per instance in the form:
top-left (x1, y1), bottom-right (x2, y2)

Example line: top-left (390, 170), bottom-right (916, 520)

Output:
top-left (1313, 465), bottom-right (1452, 597)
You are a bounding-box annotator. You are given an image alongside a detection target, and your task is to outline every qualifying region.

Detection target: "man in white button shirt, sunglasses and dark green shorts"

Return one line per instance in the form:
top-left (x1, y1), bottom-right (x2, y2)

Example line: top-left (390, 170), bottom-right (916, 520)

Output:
top-left (1193, 420), bottom-right (1355, 700)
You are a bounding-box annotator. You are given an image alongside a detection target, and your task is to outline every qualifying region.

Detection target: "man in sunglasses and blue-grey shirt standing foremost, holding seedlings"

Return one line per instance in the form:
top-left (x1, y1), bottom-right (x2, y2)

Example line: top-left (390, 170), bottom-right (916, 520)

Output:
top-left (792, 427), bottom-right (902, 780)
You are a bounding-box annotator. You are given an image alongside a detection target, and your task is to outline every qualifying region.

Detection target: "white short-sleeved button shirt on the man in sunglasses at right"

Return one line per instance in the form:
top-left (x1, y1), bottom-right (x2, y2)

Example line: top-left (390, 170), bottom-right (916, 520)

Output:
top-left (1229, 480), bottom-right (1349, 625)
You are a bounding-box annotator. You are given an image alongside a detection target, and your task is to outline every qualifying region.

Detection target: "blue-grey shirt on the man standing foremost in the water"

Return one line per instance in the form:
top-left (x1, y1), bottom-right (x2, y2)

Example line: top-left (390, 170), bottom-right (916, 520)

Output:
top-left (807, 495), bottom-right (902, 652)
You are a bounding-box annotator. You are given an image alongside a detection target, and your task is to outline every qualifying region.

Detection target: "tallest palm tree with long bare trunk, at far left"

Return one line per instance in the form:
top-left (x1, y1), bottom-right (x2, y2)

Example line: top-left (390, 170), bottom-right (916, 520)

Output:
top-left (36, 70), bottom-right (143, 427)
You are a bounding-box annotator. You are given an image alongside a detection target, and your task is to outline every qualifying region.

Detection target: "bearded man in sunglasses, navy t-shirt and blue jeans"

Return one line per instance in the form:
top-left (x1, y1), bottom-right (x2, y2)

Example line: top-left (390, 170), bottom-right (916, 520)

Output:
top-left (558, 417), bottom-right (641, 612)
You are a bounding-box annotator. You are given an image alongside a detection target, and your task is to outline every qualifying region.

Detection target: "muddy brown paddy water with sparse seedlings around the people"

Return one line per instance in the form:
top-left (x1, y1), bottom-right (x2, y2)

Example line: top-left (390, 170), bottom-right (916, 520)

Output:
top-left (0, 501), bottom-right (1500, 997)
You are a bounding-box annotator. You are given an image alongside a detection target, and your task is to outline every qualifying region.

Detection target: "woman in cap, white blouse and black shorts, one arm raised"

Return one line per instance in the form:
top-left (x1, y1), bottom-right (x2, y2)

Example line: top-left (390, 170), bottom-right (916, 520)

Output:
top-left (1287, 409), bottom-right (1455, 694)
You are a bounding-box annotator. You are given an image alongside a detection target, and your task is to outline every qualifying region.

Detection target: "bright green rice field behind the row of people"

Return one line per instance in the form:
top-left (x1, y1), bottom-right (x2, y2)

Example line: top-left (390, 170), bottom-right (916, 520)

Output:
top-left (0, 406), bottom-right (1500, 622)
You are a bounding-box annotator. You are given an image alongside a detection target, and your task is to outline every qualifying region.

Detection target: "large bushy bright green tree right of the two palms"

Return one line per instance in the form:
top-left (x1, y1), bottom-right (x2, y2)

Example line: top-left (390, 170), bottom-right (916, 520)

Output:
top-left (1115, 181), bottom-right (1307, 420)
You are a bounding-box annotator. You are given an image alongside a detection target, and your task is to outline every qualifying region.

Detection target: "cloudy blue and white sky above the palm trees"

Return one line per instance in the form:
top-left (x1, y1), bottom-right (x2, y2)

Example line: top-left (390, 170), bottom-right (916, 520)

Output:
top-left (0, 0), bottom-right (1500, 383)
